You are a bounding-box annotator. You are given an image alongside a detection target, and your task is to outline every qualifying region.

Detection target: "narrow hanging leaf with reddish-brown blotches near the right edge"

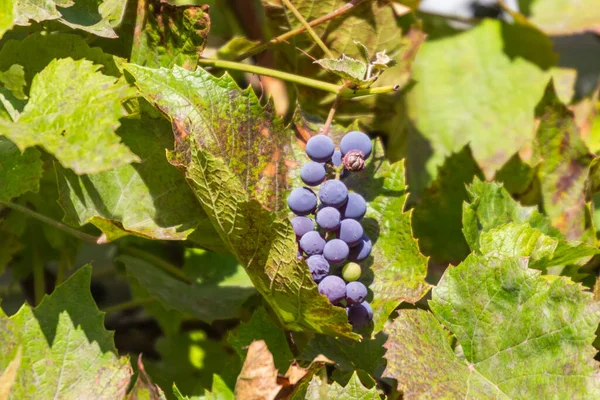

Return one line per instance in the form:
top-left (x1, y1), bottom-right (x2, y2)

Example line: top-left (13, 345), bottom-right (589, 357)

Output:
top-left (533, 82), bottom-right (593, 240)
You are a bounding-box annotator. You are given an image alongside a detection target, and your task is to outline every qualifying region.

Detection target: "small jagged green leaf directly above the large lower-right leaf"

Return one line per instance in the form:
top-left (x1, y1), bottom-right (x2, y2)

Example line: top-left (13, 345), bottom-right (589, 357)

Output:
top-left (463, 178), bottom-right (562, 251)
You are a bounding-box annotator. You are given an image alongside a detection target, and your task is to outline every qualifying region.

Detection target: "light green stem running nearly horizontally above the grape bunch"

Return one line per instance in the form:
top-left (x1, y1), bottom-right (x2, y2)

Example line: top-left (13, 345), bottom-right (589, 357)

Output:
top-left (198, 58), bottom-right (400, 99)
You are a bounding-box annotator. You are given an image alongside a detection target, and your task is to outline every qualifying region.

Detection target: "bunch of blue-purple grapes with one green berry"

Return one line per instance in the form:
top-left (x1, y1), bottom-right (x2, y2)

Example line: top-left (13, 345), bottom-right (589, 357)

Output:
top-left (288, 131), bottom-right (373, 328)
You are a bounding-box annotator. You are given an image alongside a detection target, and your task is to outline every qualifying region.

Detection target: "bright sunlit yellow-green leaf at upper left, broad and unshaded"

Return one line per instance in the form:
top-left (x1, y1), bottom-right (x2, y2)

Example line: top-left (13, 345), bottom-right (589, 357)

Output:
top-left (0, 59), bottom-right (139, 174)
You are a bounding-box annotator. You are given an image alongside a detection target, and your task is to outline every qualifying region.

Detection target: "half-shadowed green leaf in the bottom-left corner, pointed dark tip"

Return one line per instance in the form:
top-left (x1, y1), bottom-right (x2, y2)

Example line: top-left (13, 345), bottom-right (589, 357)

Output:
top-left (0, 266), bottom-right (132, 399)
